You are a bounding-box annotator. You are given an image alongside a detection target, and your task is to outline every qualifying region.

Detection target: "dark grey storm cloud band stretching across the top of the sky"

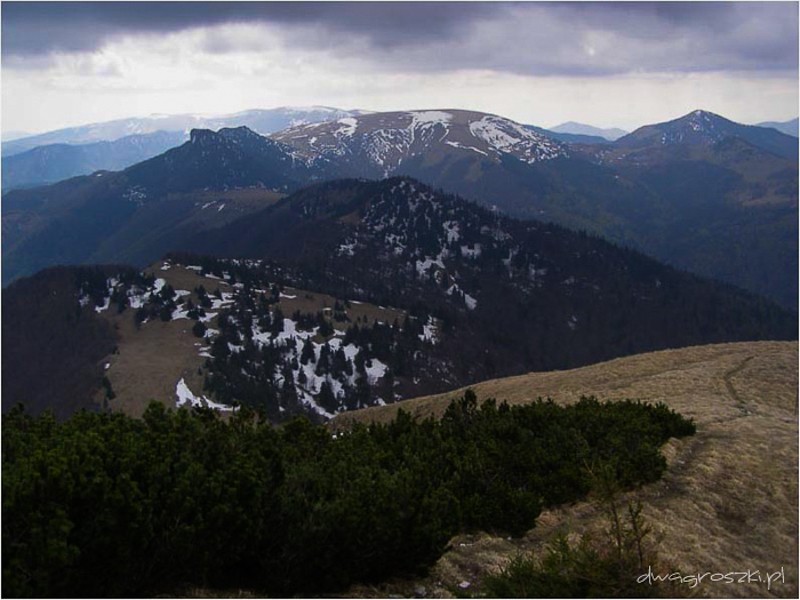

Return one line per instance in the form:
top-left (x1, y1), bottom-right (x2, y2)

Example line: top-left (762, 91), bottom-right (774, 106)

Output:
top-left (2, 2), bottom-right (798, 76)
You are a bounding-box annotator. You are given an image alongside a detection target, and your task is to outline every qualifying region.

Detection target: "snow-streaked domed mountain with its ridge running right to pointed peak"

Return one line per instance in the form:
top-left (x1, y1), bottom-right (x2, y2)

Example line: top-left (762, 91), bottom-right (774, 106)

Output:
top-left (274, 110), bottom-right (797, 307)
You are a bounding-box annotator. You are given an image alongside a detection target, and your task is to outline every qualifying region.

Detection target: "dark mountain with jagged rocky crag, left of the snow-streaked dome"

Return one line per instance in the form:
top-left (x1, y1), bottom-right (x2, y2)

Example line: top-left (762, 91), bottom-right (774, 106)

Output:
top-left (2, 127), bottom-right (324, 282)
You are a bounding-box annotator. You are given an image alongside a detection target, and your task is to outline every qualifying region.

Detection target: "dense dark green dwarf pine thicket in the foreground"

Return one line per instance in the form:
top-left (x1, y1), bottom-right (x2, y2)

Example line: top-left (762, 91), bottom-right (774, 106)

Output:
top-left (2, 392), bottom-right (695, 597)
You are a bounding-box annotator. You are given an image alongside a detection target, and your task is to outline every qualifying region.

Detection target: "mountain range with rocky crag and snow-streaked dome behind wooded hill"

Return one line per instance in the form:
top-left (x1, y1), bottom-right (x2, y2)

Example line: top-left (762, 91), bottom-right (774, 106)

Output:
top-left (3, 109), bottom-right (797, 309)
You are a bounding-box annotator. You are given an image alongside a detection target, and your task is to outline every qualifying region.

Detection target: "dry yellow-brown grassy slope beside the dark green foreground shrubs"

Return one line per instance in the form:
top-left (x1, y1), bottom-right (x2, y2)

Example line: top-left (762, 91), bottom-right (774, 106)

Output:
top-left (336, 342), bottom-right (798, 598)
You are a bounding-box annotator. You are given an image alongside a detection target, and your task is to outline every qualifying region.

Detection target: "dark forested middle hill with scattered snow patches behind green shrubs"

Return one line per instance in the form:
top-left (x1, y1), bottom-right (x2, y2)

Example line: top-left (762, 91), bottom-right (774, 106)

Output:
top-left (3, 176), bottom-right (797, 421)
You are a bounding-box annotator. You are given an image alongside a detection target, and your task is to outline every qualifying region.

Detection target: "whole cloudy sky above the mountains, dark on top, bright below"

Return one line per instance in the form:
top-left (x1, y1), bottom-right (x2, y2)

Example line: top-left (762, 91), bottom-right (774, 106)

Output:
top-left (0, 0), bottom-right (798, 132)
